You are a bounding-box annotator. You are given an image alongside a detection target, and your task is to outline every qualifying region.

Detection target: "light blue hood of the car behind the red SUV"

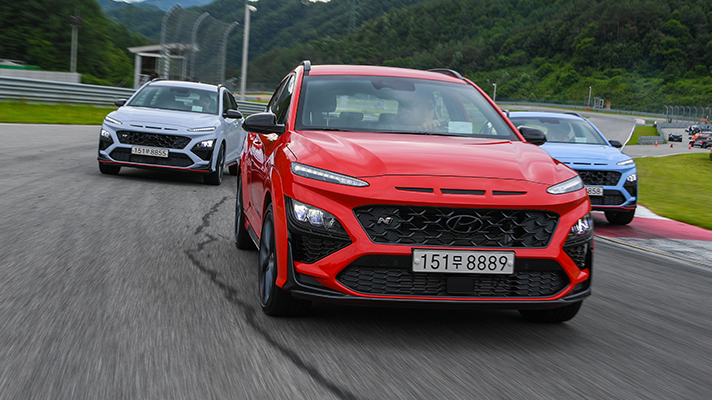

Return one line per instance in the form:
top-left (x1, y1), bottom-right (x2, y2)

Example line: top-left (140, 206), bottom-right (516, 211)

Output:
top-left (541, 143), bottom-right (630, 165)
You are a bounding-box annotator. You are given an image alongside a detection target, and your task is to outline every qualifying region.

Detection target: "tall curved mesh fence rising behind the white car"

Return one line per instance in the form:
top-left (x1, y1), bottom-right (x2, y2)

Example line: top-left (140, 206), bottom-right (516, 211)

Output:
top-left (158, 4), bottom-right (237, 84)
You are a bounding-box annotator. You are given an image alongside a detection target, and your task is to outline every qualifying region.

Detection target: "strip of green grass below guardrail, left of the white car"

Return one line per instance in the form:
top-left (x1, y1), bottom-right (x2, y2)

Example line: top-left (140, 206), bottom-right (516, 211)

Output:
top-left (0, 101), bottom-right (116, 125)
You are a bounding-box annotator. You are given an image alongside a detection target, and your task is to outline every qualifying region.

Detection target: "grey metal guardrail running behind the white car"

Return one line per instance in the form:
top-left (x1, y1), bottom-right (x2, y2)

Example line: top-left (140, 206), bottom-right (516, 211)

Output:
top-left (0, 76), bottom-right (265, 116)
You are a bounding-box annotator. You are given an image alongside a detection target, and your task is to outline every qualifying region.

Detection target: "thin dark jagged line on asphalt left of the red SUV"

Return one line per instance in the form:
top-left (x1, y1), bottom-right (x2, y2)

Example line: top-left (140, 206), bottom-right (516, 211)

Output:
top-left (185, 197), bottom-right (358, 400)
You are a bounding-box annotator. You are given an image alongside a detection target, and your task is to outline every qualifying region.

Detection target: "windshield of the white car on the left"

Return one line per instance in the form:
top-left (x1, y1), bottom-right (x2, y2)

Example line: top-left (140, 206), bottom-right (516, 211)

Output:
top-left (127, 85), bottom-right (218, 114)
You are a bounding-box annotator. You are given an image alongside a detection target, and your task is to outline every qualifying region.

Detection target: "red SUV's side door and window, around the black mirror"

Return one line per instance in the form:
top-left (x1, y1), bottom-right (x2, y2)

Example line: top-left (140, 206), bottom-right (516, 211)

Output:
top-left (246, 75), bottom-right (294, 226)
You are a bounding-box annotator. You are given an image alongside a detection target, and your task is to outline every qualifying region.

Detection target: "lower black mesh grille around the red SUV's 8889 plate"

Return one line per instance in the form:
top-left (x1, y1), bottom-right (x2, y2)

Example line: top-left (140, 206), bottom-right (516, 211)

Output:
top-left (337, 256), bottom-right (569, 298)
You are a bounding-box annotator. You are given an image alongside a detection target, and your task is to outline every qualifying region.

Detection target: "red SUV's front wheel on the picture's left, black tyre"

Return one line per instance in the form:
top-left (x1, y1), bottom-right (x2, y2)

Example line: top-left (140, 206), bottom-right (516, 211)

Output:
top-left (258, 206), bottom-right (311, 317)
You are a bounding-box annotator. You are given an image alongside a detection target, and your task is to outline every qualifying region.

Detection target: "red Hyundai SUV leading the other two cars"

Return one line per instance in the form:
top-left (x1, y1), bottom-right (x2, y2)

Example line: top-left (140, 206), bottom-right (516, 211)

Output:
top-left (235, 61), bottom-right (593, 322)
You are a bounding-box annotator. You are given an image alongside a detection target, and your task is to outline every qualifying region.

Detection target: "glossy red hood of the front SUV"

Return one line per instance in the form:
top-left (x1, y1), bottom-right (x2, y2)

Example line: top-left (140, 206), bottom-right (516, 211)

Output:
top-left (288, 131), bottom-right (576, 185)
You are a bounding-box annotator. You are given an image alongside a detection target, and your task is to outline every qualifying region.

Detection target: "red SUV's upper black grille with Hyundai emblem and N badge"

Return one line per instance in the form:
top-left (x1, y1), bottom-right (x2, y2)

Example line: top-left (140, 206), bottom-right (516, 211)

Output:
top-left (354, 205), bottom-right (559, 247)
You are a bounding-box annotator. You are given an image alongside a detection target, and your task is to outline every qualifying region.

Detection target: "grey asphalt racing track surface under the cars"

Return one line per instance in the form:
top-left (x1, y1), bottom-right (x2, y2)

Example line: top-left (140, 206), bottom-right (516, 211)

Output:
top-left (0, 123), bottom-right (712, 400)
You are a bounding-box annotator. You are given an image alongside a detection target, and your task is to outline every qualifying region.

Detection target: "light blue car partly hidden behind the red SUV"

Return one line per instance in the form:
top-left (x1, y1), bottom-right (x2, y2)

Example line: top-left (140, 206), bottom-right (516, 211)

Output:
top-left (509, 111), bottom-right (638, 225)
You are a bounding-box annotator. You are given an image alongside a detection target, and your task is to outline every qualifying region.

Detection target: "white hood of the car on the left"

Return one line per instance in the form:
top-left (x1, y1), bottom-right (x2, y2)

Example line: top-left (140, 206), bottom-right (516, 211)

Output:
top-left (109, 106), bottom-right (218, 129)
